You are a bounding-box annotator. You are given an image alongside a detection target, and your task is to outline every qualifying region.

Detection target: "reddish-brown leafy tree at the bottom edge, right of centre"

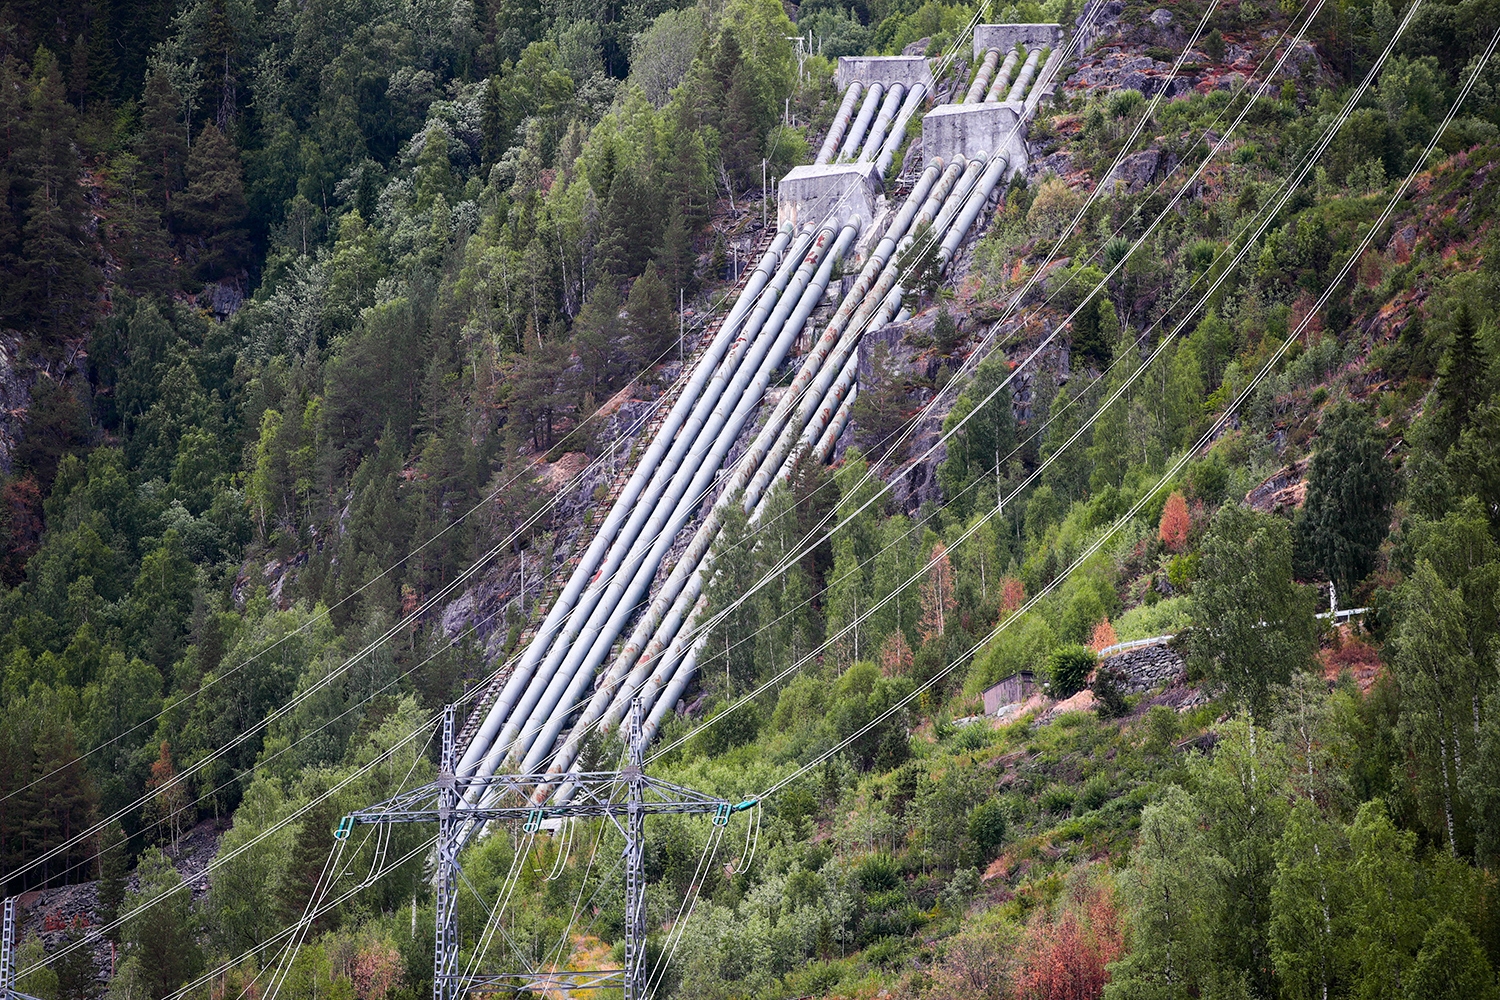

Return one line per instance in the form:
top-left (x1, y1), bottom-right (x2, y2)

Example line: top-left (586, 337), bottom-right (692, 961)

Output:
top-left (1014, 879), bottom-right (1124, 1000)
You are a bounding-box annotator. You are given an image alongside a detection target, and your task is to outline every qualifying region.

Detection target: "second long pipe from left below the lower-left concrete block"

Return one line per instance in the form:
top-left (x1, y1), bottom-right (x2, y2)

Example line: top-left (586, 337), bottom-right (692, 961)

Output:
top-left (480, 226), bottom-right (812, 777)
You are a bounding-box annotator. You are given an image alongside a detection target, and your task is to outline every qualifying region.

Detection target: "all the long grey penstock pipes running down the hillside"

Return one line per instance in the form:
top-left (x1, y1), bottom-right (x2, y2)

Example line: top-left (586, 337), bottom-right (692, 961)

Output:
top-left (459, 23), bottom-right (1052, 832)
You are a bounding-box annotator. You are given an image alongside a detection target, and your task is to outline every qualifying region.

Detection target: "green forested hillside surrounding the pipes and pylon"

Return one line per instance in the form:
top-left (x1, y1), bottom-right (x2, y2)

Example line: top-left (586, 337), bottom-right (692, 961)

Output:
top-left (0, 0), bottom-right (1500, 1000)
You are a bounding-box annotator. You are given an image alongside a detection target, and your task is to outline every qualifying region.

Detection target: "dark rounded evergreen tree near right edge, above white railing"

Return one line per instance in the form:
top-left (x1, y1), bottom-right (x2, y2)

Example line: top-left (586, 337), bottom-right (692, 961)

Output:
top-left (1298, 403), bottom-right (1395, 603)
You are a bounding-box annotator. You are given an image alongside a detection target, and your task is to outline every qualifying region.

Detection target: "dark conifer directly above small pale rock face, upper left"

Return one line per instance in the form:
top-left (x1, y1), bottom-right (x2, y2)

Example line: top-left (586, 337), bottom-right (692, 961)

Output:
top-left (174, 124), bottom-right (249, 280)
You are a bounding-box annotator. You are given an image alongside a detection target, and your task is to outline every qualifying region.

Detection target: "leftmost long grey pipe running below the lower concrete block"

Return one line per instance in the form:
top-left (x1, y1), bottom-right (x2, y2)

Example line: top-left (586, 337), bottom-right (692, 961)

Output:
top-left (459, 226), bottom-right (792, 777)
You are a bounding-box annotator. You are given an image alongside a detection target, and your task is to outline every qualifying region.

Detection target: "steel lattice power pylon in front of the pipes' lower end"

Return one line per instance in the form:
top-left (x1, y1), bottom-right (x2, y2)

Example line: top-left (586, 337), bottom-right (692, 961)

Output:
top-left (345, 699), bottom-right (756, 1000)
